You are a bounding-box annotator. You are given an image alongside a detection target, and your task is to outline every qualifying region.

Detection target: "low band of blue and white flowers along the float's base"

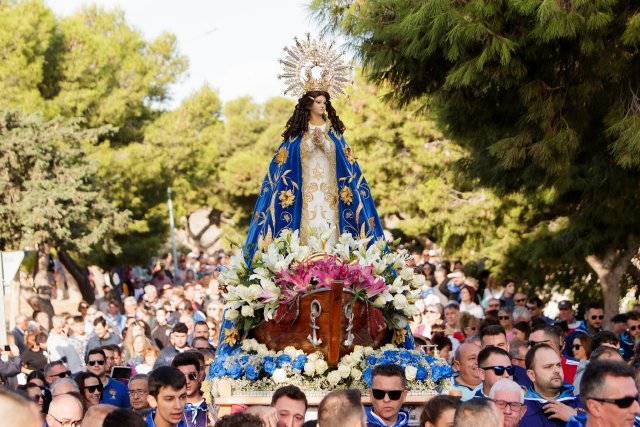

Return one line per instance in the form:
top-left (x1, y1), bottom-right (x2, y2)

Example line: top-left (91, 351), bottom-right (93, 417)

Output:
top-left (203, 339), bottom-right (453, 398)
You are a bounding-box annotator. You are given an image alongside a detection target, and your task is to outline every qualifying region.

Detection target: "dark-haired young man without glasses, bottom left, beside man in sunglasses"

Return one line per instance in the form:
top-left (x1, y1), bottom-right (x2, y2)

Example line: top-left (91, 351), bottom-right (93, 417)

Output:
top-left (145, 366), bottom-right (187, 427)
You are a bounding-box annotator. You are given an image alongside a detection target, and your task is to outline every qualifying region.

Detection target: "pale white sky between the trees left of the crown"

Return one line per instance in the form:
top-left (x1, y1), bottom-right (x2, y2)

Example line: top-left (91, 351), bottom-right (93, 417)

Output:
top-left (45, 0), bottom-right (340, 108)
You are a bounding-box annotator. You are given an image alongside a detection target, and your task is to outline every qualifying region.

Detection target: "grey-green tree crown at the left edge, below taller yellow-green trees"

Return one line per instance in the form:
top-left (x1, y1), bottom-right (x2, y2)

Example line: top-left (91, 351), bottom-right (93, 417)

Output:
top-left (0, 110), bottom-right (128, 253)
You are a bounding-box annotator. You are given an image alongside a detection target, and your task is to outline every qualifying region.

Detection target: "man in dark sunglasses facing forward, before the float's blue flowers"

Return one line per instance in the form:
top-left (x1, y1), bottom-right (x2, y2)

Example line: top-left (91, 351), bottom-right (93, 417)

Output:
top-left (365, 364), bottom-right (409, 427)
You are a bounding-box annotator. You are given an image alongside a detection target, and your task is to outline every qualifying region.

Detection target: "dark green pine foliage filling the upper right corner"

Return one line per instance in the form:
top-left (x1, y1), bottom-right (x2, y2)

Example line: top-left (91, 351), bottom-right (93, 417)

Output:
top-left (312, 0), bottom-right (640, 292)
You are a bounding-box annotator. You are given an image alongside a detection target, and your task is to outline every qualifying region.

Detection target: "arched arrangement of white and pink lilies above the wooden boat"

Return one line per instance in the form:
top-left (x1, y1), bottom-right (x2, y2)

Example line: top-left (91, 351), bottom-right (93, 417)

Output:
top-left (220, 229), bottom-right (424, 331)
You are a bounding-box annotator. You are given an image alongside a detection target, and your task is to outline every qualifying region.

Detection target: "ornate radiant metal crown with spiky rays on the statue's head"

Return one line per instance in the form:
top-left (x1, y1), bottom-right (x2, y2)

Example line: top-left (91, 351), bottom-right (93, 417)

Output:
top-left (278, 34), bottom-right (353, 98)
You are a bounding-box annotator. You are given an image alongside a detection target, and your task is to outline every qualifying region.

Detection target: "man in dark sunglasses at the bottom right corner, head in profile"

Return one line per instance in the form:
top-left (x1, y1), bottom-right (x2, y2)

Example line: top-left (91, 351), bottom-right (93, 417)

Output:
top-left (580, 361), bottom-right (640, 427)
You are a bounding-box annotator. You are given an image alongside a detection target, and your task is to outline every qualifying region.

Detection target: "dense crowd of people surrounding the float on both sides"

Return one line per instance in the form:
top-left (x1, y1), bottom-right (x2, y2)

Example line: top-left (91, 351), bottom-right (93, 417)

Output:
top-left (0, 251), bottom-right (640, 427)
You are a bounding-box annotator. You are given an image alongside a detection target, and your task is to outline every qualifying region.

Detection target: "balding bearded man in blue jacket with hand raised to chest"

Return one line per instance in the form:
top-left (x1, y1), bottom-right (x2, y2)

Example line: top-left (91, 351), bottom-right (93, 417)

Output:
top-left (520, 344), bottom-right (582, 427)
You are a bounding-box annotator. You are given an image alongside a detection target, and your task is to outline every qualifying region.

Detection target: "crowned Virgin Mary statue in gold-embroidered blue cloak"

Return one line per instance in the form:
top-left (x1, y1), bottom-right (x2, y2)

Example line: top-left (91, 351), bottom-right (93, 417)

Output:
top-left (244, 37), bottom-right (383, 260)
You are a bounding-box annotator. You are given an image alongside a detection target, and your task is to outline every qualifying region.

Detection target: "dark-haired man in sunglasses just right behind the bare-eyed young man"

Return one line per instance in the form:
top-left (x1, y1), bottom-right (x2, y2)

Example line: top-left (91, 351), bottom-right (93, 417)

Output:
top-left (171, 351), bottom-right (213, 427)
